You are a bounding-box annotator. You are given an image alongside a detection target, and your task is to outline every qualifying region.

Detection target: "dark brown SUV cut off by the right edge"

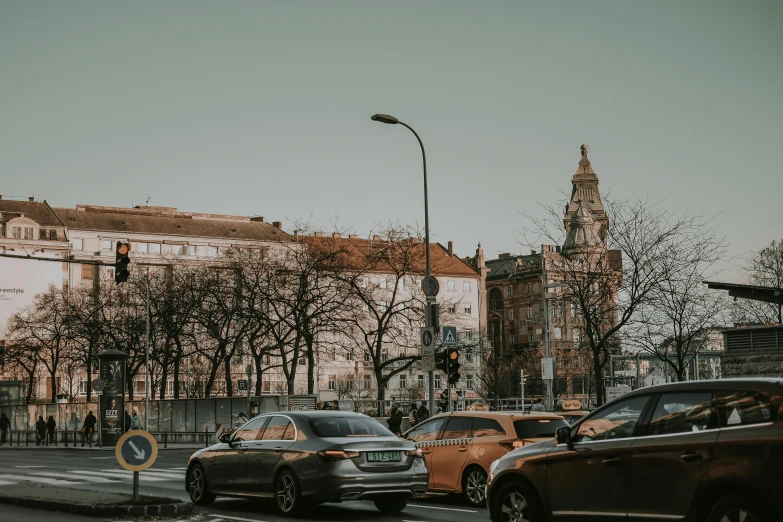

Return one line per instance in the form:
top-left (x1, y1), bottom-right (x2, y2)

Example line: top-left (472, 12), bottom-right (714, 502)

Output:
top-left (487, 379), bottom-right (783, 522)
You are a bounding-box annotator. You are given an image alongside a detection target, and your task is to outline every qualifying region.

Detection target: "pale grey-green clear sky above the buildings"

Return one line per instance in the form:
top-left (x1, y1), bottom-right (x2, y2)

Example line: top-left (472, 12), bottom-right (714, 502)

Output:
top-left (0, 0), bottom-right (783, 281)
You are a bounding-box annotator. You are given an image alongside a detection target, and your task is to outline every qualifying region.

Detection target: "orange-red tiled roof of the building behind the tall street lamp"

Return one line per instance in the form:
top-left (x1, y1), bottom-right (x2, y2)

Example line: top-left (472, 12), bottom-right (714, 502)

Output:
top-left (301, 236), bottom-right (478, 278)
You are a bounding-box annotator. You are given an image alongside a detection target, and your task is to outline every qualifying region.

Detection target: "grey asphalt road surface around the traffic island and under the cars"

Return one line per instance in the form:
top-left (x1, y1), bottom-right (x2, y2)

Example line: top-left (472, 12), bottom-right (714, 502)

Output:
top-left (0, 448), bottom-right (489, 522)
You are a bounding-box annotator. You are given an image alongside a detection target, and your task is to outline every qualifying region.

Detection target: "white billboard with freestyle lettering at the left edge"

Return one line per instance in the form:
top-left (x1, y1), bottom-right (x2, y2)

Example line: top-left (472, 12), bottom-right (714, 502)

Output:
top-left (0, 253), bottom-right (63, 339)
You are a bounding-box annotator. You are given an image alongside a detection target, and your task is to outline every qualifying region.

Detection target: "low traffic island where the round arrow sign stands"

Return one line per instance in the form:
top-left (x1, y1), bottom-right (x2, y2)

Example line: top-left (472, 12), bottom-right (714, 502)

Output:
top-left (0, 484), bottom-right (193, 517)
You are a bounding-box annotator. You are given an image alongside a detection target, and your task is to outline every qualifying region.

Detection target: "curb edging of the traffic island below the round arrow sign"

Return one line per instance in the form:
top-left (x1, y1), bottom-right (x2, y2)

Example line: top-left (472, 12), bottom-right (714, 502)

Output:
top-left (0, 495), bottom-right (193, 517)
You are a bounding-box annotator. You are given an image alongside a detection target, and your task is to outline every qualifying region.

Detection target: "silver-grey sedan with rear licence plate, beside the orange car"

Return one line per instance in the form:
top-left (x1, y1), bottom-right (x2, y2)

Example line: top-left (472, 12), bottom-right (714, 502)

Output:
top-left (185, 411), bottom-right (429, 515)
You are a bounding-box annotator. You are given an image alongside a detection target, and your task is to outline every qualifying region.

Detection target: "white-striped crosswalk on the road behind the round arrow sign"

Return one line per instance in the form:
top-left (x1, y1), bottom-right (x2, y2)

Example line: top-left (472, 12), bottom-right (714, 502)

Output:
top-left (0, 467), bottom-right (187, 486)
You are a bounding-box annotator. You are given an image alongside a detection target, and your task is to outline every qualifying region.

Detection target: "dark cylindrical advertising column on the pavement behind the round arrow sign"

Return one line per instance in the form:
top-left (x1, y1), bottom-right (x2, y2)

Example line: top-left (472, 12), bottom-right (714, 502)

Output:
top-left (98, 348), bottom-right (128, 446)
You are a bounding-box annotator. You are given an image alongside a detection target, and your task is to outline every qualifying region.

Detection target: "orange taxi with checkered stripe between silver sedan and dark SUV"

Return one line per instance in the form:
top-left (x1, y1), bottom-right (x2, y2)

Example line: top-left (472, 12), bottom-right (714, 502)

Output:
top-left (403, 411), bottom-right (568, 506)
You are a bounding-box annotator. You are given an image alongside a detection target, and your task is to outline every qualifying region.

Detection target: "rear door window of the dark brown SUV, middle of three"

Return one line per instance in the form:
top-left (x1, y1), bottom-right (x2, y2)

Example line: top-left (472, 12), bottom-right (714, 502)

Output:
top-left (647, 391), bottom-right (718, 435)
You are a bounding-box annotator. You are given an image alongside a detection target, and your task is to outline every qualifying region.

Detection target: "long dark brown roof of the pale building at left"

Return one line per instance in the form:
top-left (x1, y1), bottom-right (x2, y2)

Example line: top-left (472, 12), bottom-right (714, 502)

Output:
top-left (54, 207), bottom-right (291, 241)
